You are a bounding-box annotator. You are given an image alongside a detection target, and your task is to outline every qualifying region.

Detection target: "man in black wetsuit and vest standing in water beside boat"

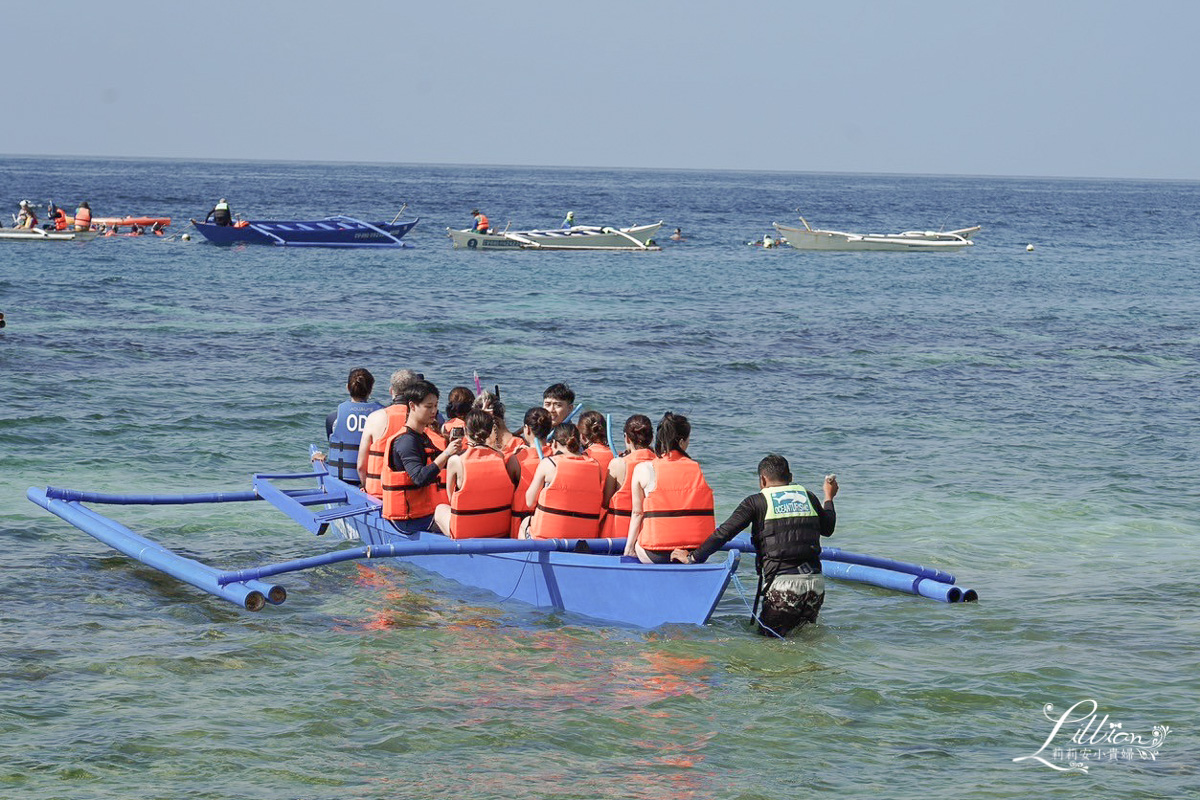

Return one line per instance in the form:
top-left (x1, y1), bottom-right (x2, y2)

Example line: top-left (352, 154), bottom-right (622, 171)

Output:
top-left (671, 453), bottom-right (838, 637)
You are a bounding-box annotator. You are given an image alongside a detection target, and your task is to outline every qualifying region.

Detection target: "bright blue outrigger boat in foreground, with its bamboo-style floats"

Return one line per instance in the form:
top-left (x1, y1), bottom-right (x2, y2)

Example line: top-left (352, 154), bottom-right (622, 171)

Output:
top-left (26, 462), bottom-right (978, 628)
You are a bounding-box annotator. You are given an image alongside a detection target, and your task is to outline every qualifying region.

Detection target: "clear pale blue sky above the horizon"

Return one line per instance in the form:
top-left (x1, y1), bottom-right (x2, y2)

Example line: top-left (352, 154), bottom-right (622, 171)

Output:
top-left (9, 0), bottom-right (1200, 180)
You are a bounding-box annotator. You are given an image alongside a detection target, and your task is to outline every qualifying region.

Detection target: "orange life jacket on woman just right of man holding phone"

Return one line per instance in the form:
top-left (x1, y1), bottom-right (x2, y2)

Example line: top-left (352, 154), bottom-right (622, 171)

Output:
top-left (444, 445), bottom-right (512, 539)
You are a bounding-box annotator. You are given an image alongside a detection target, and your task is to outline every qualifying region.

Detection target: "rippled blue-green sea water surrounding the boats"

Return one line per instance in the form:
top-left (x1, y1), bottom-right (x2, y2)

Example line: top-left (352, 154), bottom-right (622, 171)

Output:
top-left (0, 158), bottom-right (1200, 800)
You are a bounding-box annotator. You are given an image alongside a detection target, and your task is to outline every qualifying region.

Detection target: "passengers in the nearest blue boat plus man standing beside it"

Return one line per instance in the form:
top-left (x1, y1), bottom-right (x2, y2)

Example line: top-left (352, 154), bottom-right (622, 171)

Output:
top-left (318, 368), bottom-right (838, 636)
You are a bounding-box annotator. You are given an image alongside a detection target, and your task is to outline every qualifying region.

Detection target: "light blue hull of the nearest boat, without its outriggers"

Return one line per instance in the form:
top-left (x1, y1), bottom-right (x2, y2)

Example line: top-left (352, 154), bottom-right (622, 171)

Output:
top-left (324, 476), bottom-right (738, 628)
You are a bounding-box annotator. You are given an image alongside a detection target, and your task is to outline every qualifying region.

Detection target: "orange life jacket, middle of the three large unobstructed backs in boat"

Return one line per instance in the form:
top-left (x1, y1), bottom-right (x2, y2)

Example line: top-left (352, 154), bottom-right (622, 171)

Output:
top-left (529, 453), bottom-right (604, 539)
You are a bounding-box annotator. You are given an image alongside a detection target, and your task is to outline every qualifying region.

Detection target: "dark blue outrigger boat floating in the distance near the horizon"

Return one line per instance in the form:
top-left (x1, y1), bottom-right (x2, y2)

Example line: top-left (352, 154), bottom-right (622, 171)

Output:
top-left (191, 215), bottom-right (420, 247)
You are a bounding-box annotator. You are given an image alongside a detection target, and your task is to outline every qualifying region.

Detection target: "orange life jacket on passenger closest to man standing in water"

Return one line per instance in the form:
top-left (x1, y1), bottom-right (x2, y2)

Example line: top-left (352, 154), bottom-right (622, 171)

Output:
top-left (637, 450), bottom-right (716, 551)
